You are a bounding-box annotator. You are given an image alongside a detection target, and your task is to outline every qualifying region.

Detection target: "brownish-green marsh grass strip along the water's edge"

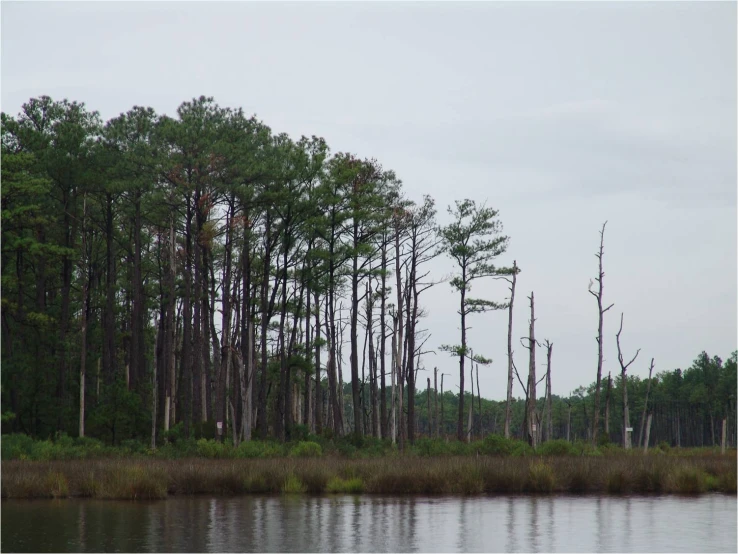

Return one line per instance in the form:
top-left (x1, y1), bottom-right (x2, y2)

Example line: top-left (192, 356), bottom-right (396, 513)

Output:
top-left (2, 455), bottom-right (736, 499)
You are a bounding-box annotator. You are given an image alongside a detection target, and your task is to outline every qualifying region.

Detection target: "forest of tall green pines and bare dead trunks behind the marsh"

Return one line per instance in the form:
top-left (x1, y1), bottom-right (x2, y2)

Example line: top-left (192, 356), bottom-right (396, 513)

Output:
top-left (1, 96), bottom-right (737, 449)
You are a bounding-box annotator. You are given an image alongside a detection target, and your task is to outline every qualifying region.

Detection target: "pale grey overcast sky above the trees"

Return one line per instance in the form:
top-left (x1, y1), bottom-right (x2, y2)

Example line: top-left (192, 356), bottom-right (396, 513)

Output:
top-left (0, 1), bottom-right (738, 399)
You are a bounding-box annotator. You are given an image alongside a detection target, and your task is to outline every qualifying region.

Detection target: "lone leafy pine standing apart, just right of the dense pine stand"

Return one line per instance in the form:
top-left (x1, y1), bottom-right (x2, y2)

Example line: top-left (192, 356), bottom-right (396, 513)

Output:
top-left (439, 199), bottom-right (513, 440)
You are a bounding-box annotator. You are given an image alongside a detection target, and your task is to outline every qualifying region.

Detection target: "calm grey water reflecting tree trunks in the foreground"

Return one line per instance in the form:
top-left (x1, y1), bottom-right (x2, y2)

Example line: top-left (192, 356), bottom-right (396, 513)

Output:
top-left (0, 494), bottom-right (737, 552)
